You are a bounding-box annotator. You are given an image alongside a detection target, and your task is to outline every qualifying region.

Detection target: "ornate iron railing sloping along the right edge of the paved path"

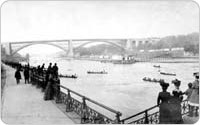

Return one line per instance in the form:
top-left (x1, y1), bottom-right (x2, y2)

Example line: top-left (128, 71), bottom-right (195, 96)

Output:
top-left (31, 72), bottom-right (122, 124)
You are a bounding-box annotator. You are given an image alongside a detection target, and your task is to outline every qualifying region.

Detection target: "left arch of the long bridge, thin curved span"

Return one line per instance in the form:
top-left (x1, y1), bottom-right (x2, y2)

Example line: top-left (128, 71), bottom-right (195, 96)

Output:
top-left (11, 43), bottom-right (69, 55)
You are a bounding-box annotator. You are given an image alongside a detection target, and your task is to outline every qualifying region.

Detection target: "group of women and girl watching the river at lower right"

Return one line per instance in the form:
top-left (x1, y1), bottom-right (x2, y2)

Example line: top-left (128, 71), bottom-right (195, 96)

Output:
top-left (157, 74), bottom-right (199, 124)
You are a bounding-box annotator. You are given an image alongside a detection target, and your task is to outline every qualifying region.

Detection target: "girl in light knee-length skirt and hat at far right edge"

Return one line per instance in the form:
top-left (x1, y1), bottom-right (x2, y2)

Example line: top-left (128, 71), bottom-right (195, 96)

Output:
top-left (188, 74), bottom-right (199, 116)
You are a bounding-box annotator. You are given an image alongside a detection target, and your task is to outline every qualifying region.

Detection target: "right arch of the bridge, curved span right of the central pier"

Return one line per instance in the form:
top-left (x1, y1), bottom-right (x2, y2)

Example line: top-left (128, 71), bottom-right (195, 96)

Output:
top-left (75, 41), bottom-right (125, 51)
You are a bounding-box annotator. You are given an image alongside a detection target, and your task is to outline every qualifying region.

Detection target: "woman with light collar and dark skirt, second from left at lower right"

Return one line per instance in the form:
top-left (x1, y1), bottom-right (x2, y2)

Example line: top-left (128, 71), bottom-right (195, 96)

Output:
top-left (170, 79), bottom-right (183, 124)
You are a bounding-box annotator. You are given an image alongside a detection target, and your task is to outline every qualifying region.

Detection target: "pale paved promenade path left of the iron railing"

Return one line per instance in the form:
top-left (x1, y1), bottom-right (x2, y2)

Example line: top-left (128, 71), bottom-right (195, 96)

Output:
top-left (2, 66), bottom-right (74, 125)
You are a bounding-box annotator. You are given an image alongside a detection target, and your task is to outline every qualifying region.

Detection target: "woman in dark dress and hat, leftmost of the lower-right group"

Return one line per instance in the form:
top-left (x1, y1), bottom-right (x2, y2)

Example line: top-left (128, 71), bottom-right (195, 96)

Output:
top-left (157, 81), bottom-right (171, 124)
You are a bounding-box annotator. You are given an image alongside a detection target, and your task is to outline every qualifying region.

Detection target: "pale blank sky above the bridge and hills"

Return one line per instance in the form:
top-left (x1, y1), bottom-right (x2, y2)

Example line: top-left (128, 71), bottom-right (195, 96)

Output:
top-left (1, 0), bottom-right (199, 54)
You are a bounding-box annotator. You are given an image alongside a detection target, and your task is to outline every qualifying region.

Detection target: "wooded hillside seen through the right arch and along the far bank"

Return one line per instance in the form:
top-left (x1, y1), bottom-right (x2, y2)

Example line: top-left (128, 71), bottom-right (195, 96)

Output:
top-left (78, 33), bottom-right (199, 55)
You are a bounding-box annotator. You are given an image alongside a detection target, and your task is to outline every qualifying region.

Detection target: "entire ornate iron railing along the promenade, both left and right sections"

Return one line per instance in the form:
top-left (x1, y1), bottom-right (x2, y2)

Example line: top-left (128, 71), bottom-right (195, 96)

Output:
top-left (2, 63), bottom-right (189, 124)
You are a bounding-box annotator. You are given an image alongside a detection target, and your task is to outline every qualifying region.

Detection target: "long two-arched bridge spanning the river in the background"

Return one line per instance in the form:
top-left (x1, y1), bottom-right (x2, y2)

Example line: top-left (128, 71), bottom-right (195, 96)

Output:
top-left (1, 39), bottom-right (159, 56)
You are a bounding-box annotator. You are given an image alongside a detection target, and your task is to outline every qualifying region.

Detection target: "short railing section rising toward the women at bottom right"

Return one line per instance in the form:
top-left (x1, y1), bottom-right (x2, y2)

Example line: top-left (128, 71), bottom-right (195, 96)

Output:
top-left (120, 100), bottom-right (188, 124)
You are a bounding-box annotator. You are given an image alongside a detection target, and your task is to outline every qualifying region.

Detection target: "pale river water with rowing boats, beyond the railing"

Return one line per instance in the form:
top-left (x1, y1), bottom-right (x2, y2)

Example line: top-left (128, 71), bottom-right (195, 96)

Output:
top-left (30, 58), bottom-right (199, 118)
